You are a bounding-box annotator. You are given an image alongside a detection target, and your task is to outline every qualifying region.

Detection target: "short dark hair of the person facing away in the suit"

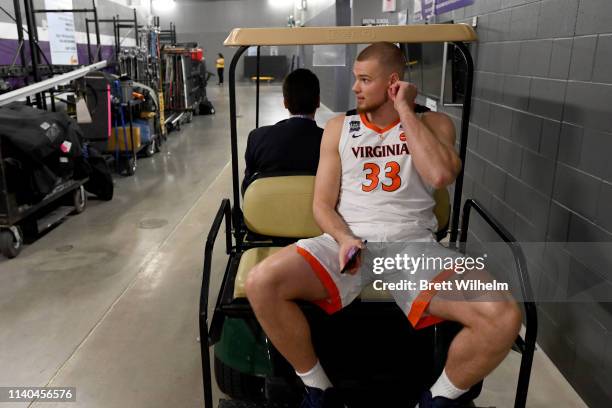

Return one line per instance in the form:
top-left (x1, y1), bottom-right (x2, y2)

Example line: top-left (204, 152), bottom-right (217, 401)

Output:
top-left (283, 68), bottom-right (321, 115)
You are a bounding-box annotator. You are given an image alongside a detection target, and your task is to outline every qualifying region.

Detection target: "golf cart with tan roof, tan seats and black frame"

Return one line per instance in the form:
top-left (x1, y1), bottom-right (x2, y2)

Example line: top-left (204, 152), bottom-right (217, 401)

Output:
top-left (199, 24), bottom-right (537, 408)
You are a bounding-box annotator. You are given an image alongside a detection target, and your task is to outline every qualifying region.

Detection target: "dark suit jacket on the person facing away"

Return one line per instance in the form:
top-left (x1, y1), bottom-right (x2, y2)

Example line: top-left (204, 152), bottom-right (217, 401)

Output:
top-left (242, 117), bottom-right (323, 191)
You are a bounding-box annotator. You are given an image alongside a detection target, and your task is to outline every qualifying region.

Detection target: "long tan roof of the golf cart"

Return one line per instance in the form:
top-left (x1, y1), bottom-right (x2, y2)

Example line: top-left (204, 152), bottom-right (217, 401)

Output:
top-left (224, 24), bottom-right (477, 47)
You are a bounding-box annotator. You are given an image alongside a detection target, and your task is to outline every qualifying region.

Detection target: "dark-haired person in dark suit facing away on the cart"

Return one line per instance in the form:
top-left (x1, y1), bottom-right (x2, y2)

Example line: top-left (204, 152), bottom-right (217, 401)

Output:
top-left (242, 68), bottom-right (323, 192)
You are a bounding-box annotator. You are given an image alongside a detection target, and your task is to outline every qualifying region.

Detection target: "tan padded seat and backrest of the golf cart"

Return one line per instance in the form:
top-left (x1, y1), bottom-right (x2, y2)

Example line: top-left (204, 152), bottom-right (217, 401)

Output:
top-left (233, 176), bottom-right (450, 301)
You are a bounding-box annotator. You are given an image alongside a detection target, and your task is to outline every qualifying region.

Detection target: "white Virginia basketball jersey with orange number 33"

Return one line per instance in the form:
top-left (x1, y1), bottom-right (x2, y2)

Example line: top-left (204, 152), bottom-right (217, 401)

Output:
top-left (337, 111), bottom-right (437, 242)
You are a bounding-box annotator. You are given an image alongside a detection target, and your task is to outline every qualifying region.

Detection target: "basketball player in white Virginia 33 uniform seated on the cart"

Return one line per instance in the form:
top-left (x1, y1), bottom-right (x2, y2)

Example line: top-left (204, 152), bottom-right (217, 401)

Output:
top-left (246, 43), bottom-right (521, 408)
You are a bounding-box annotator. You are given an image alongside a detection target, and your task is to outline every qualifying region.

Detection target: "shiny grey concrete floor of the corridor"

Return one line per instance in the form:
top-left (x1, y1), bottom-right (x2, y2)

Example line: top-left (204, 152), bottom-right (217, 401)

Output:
top-left (0, 85), bottom-right (586, 408)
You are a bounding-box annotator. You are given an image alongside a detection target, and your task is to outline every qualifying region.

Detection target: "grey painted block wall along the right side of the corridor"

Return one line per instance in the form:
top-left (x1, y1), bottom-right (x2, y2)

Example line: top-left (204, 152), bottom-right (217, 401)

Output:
top-left (400, 0), bottom-right (612, 407)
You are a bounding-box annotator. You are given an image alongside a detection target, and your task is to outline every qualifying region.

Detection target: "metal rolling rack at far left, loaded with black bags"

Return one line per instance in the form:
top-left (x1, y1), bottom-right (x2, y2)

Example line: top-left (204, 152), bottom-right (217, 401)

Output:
top-left (0, 0), bottom-right (106, 258)
